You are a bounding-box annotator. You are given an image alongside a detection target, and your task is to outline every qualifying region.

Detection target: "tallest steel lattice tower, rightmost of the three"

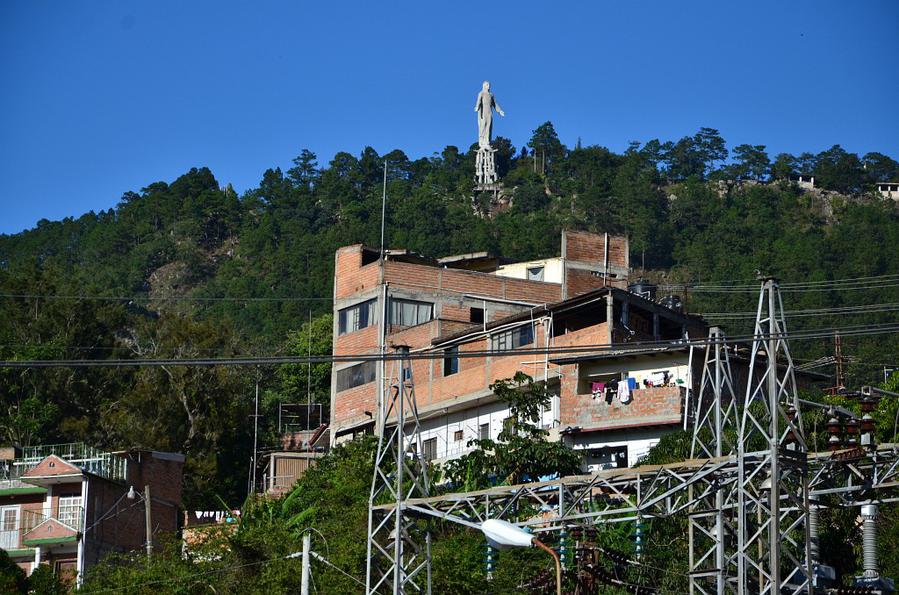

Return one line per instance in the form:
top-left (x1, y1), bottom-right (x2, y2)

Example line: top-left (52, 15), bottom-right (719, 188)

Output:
top-left (736, 278), bottom-right (812, 595)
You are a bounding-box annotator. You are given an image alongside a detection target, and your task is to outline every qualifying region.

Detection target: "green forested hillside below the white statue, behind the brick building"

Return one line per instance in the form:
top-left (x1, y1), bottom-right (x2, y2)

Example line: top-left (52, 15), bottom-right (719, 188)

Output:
top-left (0, 122), bottom-right (899, 507)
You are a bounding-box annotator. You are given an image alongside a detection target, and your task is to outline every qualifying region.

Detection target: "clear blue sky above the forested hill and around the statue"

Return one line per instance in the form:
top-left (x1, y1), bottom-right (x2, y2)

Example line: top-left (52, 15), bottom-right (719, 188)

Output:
top-left (0, 0), bottom-right (899, 233)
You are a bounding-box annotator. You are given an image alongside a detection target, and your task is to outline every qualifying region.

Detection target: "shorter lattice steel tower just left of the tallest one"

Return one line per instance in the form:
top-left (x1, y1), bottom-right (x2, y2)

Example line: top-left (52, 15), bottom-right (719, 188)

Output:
top-left (688, 327), bottom-right (739, 594)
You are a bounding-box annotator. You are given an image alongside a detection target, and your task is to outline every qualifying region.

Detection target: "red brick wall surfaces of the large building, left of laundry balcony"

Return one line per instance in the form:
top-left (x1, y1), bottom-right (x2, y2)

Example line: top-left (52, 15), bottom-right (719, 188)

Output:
top-left (331, 231), bottom-right (648, 438)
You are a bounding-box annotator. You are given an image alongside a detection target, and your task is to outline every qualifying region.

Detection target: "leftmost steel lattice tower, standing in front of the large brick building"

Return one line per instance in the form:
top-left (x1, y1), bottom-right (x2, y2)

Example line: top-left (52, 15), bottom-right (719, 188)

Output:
top-left (365, 346), bottom-right (431, 595)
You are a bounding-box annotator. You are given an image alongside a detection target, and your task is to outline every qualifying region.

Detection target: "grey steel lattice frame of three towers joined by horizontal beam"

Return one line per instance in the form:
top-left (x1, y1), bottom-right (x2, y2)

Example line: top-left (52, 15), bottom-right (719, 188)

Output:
top-left (367, 279), bottom-right (899, 595)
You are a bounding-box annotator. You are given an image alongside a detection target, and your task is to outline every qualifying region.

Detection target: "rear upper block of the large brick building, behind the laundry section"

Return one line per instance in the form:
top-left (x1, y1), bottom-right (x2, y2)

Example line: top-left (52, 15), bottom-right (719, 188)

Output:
top-left (330, 232), bottom-right (628, 442)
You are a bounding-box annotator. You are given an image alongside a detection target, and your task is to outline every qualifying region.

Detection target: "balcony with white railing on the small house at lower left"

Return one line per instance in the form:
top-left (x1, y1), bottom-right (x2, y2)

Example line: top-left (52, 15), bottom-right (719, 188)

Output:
top-left (0, 505), bottom-right (84, 550)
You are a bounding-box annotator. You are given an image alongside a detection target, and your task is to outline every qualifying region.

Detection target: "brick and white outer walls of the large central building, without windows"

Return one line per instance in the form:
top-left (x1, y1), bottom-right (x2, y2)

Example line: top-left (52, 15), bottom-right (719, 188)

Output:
top-left (331, 232), bottom-right (695, 472)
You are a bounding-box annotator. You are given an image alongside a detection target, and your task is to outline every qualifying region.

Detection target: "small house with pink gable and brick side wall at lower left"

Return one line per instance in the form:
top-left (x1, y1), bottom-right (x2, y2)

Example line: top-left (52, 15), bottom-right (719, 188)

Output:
top-left (0, 443), bottom-right (184, 580)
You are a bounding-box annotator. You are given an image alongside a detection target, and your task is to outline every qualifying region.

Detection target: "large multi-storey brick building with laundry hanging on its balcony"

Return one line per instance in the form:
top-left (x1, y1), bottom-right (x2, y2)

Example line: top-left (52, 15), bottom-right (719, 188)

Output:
top-left (331, 232), bottom-right (708, 469)
